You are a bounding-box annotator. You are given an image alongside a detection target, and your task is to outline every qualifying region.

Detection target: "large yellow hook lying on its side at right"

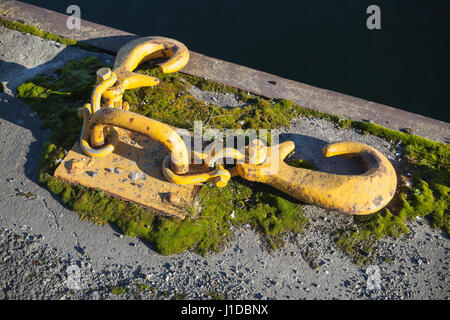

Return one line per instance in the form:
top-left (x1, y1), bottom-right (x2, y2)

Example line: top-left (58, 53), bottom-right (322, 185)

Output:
top-left (236, 141), bottom-right (397, 215)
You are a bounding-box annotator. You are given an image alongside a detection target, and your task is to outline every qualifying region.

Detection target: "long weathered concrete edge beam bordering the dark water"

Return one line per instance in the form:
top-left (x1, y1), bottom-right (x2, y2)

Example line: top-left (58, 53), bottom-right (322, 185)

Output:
top-left (0, 1), bottom-right (450, 143)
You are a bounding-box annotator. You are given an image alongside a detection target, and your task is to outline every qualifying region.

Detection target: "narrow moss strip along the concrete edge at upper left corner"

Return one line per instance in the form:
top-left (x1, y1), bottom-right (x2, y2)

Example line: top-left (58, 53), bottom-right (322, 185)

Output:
top-left (0, 19), bottom-right (99, 52)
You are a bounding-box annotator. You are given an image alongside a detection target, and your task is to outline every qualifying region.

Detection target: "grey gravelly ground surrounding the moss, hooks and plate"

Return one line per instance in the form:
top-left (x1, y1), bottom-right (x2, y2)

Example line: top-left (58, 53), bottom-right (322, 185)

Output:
top-left (0, 28), bottom-right (450, 299)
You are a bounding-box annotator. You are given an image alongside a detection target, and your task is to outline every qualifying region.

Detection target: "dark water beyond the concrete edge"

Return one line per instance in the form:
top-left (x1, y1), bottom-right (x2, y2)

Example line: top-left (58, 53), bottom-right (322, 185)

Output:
top-left (21, 0), bottom-right (450, 122)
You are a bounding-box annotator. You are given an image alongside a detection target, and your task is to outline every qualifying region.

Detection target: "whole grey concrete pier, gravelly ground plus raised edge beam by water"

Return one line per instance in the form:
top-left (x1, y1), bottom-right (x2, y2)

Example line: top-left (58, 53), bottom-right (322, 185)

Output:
top-left (0, 1), bottom-right (450, 300)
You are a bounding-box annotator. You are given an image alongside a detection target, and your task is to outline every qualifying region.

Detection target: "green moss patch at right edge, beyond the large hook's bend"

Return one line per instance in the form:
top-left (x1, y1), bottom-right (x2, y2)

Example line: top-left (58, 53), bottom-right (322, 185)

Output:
top-left (336, 121), bottom-right (450, 263)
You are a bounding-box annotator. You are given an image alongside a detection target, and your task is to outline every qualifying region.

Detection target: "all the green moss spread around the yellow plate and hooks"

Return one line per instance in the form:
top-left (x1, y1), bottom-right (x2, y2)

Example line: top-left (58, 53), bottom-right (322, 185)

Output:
top-left (17, 57), bottom-right (449, 265)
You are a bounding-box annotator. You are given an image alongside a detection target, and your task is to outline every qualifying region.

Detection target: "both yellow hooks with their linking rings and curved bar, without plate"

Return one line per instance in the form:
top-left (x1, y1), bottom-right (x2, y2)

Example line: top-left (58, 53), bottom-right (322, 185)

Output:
top-left (78, 37), bottom-right (397, 214)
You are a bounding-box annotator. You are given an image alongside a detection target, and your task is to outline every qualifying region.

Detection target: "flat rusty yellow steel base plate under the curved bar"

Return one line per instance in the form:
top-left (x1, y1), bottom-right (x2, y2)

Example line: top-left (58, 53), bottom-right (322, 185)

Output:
top-left (55, 128), bottom-right (198, 219)
